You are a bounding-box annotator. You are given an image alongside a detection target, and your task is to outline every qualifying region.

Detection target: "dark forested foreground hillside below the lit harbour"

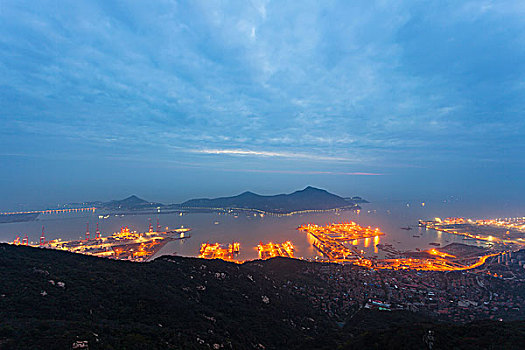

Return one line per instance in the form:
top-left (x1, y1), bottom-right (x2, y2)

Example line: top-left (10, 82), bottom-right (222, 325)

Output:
top-left (0, 244), bottom-right (525, 350)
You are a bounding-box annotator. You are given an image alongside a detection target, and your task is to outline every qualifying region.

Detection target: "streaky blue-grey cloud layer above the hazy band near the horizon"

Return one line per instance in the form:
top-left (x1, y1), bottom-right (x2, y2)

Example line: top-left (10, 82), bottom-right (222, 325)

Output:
top-left (0, 0), bottom-right (525, 180)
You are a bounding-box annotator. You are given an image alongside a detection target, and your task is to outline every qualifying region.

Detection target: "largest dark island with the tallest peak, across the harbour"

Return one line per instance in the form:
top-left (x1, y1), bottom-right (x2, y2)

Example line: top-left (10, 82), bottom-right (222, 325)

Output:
top-left (180, 186), bottom-right (357, 213)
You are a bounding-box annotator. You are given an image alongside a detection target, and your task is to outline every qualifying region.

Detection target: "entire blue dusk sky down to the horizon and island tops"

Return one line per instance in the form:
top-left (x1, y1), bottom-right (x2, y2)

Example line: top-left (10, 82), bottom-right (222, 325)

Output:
top-left (0, 0), bottom-right (525, 210)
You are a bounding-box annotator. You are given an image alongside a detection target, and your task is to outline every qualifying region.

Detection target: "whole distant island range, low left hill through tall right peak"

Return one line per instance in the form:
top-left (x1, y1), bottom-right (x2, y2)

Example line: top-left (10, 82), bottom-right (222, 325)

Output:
top-left (62, 186), bottom-right (368, 214)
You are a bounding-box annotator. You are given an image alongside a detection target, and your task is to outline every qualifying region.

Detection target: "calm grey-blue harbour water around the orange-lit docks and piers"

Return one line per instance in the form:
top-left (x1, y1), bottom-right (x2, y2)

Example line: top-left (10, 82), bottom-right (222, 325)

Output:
top-left (0, 201), bottom-right (525, 259)
